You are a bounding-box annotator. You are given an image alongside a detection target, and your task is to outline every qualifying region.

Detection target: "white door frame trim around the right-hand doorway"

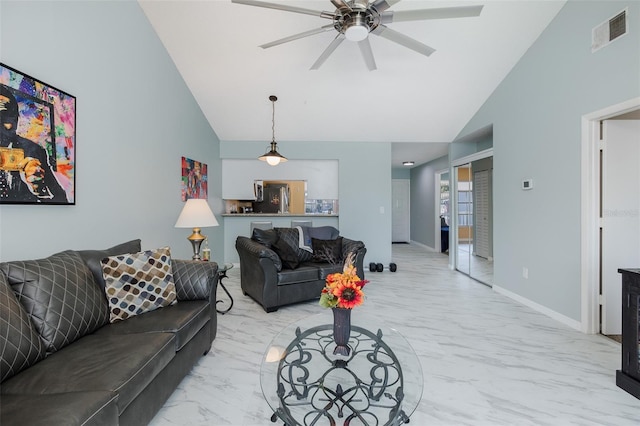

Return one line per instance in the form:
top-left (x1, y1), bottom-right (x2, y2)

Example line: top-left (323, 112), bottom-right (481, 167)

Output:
top-left (580, 97), bottom-right (640, 334)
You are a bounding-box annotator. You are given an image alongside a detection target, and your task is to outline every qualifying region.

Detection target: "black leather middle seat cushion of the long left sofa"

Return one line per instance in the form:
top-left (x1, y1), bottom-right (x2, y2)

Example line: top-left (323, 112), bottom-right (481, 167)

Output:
top-left (2, 333), bottom-right (175, 414)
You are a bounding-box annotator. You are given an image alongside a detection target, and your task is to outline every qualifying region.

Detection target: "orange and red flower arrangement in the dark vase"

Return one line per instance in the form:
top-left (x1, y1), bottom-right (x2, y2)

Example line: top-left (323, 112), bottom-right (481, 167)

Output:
top-left (320, 253), bottom-right (369, 309)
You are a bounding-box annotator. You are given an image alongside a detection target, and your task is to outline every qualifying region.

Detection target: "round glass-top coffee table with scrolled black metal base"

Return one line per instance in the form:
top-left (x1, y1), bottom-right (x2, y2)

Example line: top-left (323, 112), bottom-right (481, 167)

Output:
top-left (260, 308), bottom-right (423, 426)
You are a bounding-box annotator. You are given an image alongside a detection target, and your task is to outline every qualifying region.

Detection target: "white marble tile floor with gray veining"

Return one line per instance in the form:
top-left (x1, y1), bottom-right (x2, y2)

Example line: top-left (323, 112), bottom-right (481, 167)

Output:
top-left (151, 244), bottom-right (640, 426)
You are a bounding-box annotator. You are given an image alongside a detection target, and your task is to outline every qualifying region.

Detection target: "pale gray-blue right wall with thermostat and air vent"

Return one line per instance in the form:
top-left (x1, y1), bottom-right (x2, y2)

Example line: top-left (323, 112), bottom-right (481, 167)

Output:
top-left (461, 1), bottom-right (640, 321)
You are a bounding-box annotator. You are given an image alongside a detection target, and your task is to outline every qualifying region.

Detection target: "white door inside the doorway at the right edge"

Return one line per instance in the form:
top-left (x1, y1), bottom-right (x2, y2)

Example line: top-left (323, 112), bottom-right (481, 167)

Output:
top-left (601, 120), bottom-right (640, 335)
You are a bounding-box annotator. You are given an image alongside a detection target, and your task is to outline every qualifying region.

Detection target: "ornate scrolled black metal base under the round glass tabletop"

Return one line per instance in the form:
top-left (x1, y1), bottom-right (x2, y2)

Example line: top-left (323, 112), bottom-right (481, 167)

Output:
top-left (271, 324), bottom-right (409, 426)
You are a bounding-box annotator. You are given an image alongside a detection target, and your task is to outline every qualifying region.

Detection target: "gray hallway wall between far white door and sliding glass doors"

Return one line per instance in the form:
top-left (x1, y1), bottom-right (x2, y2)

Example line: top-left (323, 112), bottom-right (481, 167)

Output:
top-left (411, 155), bottom-right (449, 248)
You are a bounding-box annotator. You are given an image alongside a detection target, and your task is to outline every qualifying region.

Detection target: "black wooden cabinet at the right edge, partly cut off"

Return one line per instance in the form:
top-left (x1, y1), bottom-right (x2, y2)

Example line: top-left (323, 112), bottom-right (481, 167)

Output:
top-left (616, 269), bottom-right (640, 399)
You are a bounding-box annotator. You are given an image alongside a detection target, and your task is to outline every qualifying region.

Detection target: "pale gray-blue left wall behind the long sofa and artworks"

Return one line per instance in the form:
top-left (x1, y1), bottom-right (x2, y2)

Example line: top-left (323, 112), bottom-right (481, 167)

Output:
top-left (0, 0), bottom-right (223, 261)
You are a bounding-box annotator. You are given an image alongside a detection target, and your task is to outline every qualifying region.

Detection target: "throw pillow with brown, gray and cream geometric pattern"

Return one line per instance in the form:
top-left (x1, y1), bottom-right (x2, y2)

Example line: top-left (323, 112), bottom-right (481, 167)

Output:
top-left (102, 247), bottom-right (177, 322)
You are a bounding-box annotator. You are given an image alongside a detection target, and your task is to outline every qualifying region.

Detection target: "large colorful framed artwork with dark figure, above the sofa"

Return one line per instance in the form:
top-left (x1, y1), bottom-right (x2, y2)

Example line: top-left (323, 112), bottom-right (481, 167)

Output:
top-left (0, 63), bottom-right (76, 204)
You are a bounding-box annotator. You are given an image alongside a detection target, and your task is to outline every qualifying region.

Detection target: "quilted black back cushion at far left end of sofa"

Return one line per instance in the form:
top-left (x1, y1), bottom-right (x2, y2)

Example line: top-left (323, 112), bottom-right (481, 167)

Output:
top-left (0, 272), bottom-right (45, 384)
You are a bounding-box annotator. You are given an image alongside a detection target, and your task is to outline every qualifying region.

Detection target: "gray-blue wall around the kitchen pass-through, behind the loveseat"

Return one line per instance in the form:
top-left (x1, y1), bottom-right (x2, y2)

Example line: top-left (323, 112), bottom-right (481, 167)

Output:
top-left (220, 140), bottom-right (391, 264)
